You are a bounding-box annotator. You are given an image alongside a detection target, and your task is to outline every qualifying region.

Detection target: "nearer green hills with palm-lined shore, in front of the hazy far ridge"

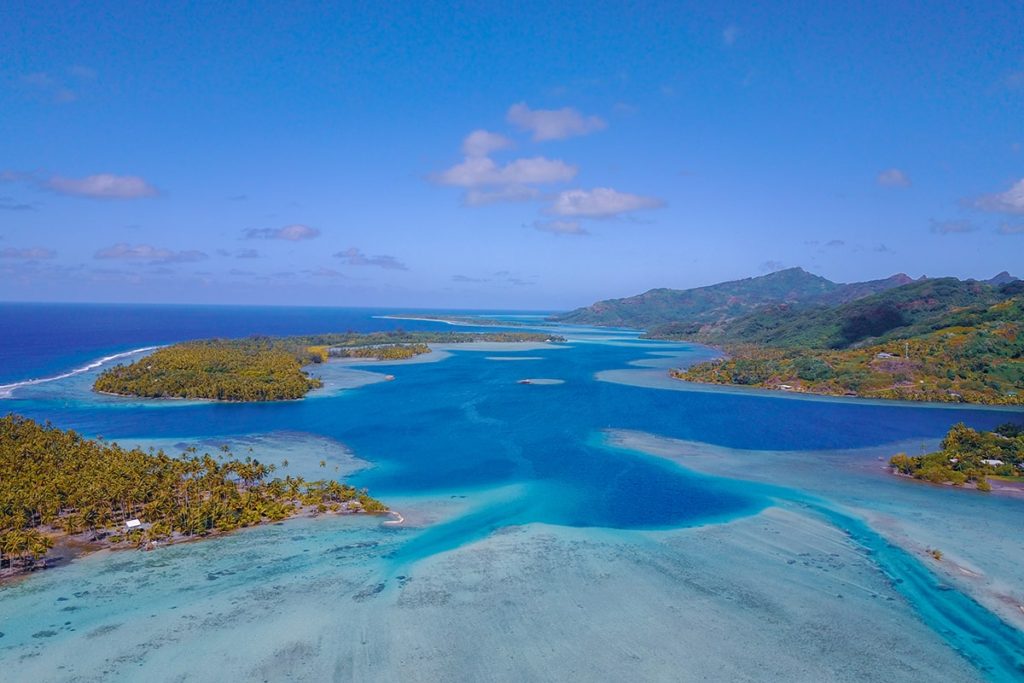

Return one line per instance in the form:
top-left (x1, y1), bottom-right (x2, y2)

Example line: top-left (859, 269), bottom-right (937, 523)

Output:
top-left (672, 278), bottom-right (1024, 404)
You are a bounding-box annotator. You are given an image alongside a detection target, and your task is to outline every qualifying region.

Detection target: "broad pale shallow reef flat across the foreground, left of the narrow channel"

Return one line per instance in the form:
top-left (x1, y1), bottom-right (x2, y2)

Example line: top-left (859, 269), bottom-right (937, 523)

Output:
top-left (0, 508), bottom-right (979, 681)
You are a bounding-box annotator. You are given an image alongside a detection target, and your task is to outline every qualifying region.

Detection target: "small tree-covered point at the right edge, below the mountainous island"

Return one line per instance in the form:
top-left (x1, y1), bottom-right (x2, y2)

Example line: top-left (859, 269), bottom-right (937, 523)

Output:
top-left (889, 423), bottom-right (1024, 492)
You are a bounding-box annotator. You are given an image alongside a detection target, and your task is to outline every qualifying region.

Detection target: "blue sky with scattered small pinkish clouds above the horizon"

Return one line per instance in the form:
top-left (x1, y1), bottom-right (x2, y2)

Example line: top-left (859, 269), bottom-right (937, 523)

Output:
top-left (0, 0), bottom-right (1024, 309)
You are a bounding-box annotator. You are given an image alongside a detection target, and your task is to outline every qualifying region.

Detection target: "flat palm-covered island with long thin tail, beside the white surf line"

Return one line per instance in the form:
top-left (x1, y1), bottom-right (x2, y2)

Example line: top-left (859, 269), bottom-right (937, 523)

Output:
top-left (93, 330), bottom-right (564, 401)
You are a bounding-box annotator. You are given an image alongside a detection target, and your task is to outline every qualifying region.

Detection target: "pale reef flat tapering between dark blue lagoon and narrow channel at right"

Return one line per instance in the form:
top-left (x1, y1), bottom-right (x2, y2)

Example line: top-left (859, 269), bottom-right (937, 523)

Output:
top-left (604, 430), bottom-right (1024, 631)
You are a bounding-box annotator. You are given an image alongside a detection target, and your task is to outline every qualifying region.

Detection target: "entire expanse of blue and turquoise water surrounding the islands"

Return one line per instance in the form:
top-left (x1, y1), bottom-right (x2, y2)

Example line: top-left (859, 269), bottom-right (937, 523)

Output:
top-left (0, 306), bottom-right (1024, 681)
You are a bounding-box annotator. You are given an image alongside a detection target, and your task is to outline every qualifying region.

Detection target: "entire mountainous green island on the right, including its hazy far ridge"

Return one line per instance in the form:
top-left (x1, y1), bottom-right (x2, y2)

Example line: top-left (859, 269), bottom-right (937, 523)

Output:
top-left (558, 268), bottom-right (1024, 404)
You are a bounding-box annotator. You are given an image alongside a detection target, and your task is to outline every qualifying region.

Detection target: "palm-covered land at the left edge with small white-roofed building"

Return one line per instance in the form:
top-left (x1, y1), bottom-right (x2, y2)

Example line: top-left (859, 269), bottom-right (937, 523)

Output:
top-left (0, 415), bottom-right (388, 578)
